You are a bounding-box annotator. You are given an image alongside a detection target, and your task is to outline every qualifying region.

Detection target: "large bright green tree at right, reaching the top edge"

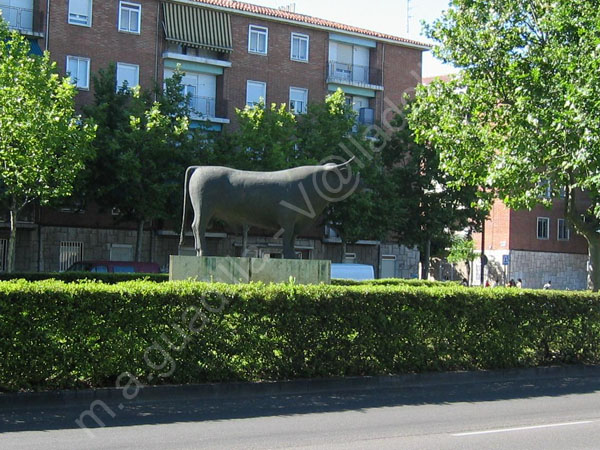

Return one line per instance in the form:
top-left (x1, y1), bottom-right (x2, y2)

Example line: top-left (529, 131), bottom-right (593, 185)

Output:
top-left (411, 0), bottom-right (600, 290)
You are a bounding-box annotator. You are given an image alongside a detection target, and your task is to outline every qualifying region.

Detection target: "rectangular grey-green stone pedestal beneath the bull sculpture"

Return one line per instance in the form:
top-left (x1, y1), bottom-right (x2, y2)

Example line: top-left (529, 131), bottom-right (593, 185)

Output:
top-left (169, 255), bottom-right (331, 284)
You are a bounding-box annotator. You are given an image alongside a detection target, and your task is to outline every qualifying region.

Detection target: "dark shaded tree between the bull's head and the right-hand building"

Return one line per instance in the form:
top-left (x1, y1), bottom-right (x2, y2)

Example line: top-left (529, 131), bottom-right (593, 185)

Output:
top-left (381, 108), bottom-right (487, 278)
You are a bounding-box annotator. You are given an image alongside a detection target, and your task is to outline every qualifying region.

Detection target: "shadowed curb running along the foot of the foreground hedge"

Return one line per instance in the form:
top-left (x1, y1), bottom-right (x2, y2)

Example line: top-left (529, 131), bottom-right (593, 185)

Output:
top-left (0, 365), bottom-right (600, 408)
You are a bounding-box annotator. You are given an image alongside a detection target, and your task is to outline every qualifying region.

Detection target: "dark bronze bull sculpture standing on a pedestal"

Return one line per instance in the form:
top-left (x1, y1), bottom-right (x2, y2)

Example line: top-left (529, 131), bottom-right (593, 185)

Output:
top-left (179, 159), bottom-right (359, 259)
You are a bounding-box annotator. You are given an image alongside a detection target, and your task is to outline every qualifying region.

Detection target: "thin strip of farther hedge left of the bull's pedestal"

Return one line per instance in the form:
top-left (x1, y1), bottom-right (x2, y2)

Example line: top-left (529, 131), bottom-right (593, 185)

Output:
top-left (0, 272), bottom-right (169, 284)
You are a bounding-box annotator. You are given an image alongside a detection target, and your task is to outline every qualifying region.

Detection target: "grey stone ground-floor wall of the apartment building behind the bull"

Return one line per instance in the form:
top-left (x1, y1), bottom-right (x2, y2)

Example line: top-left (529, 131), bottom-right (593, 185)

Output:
top-left (0, 224), bottom-right (419, 278)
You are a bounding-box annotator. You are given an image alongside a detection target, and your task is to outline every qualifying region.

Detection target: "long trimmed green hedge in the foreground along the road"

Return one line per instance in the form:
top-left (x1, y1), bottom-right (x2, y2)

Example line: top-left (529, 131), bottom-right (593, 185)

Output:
top-left (0, 280), bottom-right (600, 390)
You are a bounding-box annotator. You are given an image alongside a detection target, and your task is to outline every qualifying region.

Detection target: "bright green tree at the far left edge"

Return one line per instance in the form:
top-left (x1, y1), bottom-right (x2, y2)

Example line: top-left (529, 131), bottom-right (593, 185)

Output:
top-left (0, 21), bottom-right (95, 272)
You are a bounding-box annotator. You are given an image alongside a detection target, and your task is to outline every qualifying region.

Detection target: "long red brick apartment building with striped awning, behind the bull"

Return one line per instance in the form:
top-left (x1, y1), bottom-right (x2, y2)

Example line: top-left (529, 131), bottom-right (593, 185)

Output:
top-left (0, 0), bottom-right (428, 277)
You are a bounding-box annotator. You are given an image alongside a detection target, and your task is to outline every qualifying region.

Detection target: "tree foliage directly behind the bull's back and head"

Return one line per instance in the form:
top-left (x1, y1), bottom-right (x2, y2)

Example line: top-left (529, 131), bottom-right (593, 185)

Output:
top-left (225, 90), bottom-right (386, 250)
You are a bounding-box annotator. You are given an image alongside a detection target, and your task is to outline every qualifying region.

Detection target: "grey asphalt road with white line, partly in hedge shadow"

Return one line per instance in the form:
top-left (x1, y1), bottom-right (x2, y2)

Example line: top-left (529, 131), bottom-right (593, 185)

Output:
top-left (0, 370), bottom-right (600, 450)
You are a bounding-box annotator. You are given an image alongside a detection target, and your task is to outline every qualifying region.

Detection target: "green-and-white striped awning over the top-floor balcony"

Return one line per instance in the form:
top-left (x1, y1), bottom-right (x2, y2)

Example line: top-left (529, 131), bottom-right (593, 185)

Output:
top-left (163, 2), bottom-right (233, 52)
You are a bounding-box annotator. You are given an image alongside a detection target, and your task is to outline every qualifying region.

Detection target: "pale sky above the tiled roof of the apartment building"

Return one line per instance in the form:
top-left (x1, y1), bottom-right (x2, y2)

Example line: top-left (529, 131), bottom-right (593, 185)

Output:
top-left (244, 0), bottom-right (455, 77)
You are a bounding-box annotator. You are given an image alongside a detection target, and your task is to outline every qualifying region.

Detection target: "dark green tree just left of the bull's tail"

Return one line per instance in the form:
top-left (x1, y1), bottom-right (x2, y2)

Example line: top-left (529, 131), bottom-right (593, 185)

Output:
top-left (85, 64), bottom-right (204, 261)
